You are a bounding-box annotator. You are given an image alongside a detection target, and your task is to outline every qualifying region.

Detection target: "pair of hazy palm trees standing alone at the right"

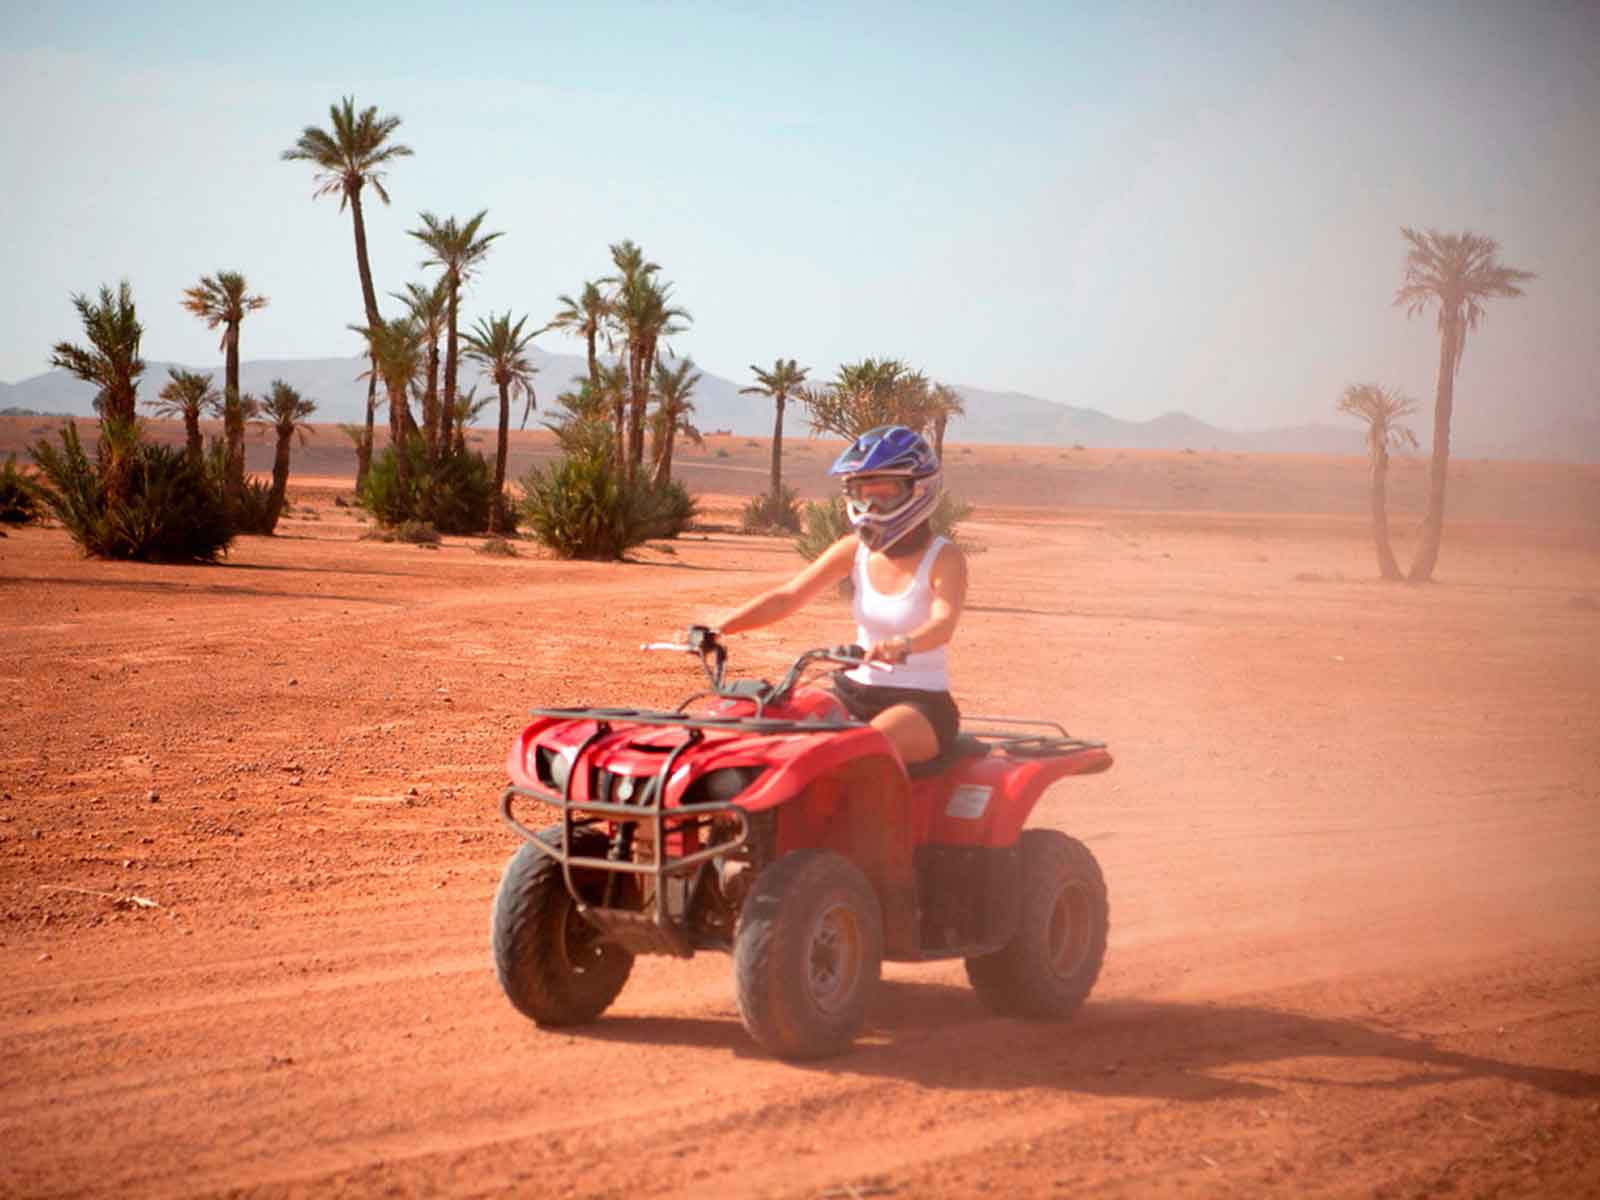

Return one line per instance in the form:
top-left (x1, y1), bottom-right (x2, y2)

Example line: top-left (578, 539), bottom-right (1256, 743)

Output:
top-left (1338, 227), bottom-right (1534, 582)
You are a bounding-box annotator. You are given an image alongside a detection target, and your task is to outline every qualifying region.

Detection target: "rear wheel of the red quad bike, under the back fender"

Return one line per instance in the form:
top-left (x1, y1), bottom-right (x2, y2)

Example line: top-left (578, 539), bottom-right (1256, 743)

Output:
top-left (966, 829), bottom-right (1110, 1021)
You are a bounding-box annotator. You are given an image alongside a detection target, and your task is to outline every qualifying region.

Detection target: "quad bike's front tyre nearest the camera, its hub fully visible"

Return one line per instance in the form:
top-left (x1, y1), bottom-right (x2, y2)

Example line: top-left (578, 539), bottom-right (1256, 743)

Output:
top-left (733, 850), bottom-right (883, 1059)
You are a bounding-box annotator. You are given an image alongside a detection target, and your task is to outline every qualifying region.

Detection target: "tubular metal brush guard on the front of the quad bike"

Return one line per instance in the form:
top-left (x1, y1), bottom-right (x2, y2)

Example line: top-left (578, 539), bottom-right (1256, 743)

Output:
top-left (501, 720), bottom-right (774, 958)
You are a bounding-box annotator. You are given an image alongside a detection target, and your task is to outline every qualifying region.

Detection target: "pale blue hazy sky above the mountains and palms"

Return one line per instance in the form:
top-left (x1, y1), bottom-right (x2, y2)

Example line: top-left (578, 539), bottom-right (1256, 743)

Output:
top-left (0, 0), bottom-right (1600, 434)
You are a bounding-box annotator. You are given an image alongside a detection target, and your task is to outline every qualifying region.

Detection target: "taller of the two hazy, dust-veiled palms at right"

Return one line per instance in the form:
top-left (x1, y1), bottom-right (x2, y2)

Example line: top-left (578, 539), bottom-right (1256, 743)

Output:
top-left (1395, 227), bottom-right (1534, 584)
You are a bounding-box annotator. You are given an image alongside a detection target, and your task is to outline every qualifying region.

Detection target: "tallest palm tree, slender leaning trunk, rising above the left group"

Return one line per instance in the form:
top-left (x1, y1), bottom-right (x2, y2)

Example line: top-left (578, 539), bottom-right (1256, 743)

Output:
top-left (282, 96), bottom-right (411, 490)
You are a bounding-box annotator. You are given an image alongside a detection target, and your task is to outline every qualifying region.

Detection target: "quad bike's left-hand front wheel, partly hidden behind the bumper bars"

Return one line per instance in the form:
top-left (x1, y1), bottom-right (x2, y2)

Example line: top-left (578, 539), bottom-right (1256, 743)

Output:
top-left (490, 826), bottom-right (634, 1026)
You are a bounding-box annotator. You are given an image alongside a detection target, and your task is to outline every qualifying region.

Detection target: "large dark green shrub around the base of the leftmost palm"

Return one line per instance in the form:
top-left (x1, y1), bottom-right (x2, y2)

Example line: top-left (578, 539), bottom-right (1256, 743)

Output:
top-left (32, 424), bottom-right (234, 562)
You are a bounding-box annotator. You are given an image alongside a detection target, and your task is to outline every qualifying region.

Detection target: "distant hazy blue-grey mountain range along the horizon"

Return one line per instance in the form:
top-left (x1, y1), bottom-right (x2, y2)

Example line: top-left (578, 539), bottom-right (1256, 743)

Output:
top-left (0, 349), bottom-right (1600, 462)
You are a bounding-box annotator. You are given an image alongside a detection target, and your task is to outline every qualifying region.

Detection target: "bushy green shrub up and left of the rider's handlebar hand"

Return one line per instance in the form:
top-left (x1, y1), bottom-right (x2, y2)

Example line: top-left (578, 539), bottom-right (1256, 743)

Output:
top-left (518, 454), bottom-right (696, 558)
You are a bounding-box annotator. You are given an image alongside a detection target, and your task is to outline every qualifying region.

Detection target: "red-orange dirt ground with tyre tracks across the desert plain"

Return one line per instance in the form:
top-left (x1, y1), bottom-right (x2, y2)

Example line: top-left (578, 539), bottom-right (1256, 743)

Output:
top-left (0, 432), bottom-right (1600, 1197)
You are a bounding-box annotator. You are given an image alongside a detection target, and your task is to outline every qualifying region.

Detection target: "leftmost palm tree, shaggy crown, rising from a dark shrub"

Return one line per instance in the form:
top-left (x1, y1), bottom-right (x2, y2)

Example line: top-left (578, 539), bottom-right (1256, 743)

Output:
top-left (50, 280), bottom-right (144, 499)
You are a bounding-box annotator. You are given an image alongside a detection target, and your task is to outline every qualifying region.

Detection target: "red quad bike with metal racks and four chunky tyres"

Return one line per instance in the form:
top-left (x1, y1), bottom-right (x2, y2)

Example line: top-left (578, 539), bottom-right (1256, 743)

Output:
top-left (491, 626), bottom-right (1112, 1059)
